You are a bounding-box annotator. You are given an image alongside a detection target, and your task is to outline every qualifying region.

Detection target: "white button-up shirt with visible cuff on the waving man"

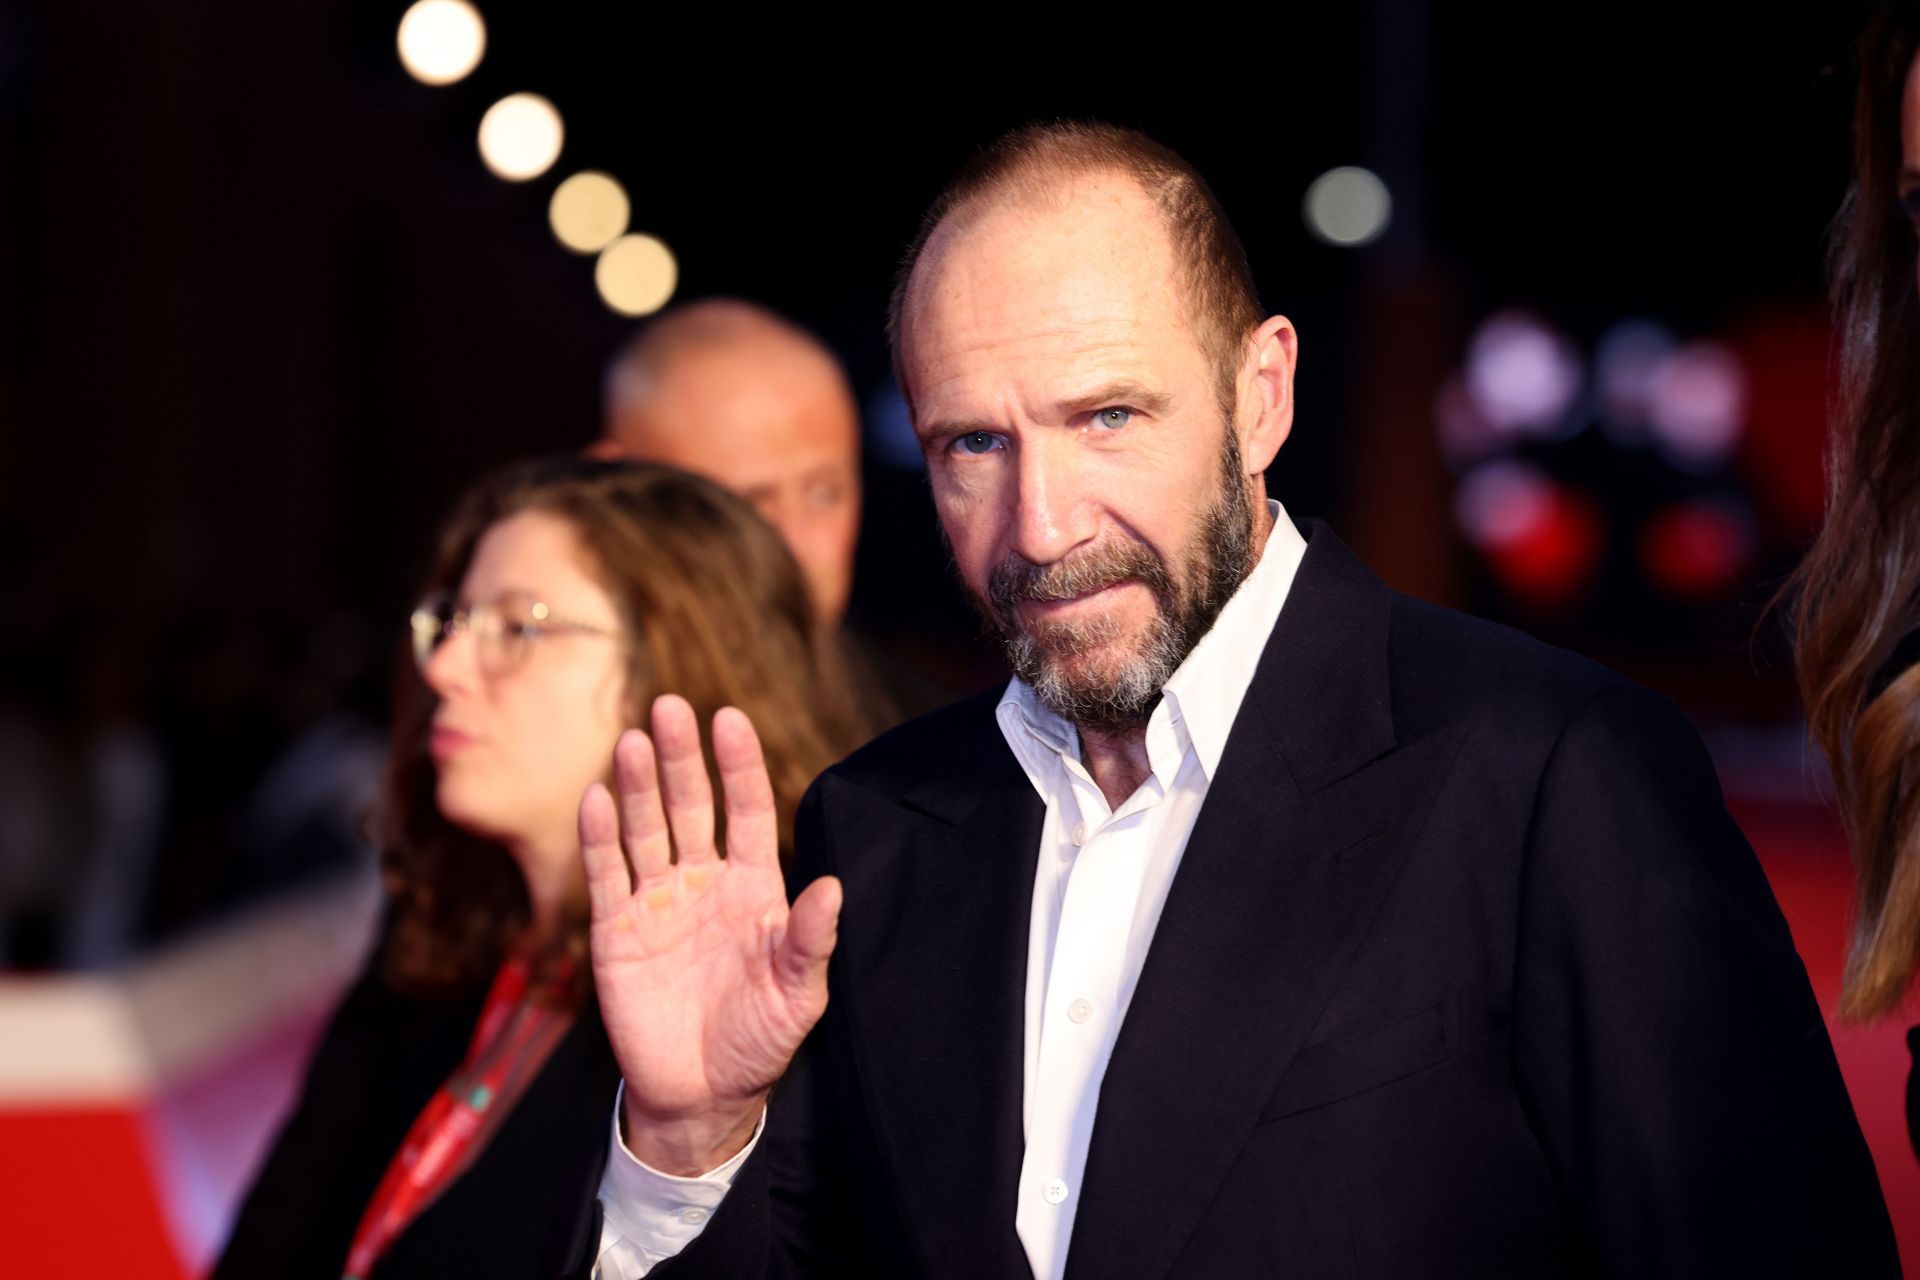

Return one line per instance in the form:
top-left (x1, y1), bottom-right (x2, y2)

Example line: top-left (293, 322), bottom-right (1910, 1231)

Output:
top-left (597, 501), bottom-right (1306, 1280)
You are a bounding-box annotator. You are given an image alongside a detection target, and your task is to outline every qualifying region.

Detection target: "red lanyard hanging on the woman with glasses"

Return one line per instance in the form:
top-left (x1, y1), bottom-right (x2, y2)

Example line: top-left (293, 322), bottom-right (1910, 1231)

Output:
top-left (344, 956), bottom-right (574, 1280)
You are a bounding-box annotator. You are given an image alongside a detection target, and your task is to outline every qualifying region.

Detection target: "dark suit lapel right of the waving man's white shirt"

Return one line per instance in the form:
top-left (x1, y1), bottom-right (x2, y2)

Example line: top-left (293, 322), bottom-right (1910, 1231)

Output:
top-left (1068, 526), bottom-right (1448, 1280)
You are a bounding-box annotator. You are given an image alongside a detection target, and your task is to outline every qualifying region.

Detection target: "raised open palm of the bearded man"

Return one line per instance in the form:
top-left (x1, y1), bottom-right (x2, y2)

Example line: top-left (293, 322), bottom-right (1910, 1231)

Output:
top-left (580, 697), bottom-right (839, 1173)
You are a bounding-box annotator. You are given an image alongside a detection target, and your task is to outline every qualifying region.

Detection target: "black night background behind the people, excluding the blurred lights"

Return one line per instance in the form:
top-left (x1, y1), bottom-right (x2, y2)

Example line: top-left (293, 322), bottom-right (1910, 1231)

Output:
top-left (0, 0), bottom-right (1864, 965)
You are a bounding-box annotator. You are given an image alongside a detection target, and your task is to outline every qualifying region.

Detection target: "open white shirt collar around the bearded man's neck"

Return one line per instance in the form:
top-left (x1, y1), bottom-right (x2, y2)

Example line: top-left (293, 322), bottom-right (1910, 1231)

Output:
top-left (995, 499), bottom-right (1308, 796)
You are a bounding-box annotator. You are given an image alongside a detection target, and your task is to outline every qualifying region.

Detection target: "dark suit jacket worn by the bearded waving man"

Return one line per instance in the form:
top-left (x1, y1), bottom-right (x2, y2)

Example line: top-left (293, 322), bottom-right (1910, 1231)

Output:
top-left (564, 522), bottom-right (1899, 1280)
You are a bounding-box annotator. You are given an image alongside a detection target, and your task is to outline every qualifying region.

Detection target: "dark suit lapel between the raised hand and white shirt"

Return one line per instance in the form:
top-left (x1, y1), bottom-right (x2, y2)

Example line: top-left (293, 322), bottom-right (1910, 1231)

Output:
top-left (835, 702), bottom-right (1044, 1276)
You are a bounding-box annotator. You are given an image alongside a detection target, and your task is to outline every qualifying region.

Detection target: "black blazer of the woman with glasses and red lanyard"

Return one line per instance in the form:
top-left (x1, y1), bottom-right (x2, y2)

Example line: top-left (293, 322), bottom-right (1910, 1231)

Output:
top-left (213, 948), bottom-right (620, 1280)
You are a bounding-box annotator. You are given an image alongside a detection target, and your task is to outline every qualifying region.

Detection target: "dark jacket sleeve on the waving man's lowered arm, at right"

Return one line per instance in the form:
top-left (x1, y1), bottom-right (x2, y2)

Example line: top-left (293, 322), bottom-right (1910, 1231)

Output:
top-left (1515, 683), bottom-right (1899, 1278)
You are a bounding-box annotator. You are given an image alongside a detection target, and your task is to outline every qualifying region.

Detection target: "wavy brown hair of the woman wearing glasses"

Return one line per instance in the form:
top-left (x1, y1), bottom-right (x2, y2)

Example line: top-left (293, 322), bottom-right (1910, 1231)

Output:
top-left (374, 457), bottom-right (868, 994)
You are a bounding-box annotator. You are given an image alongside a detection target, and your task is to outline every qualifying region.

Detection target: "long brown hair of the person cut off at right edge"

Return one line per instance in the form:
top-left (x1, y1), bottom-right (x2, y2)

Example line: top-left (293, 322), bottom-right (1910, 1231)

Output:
top-left (1789, 0), bottom-right (1920, 1019)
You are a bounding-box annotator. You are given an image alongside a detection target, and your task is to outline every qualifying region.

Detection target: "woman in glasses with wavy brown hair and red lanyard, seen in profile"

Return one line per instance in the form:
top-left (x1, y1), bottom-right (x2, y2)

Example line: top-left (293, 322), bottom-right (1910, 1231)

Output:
top-left (215, 459), bottom-right (864, 1280)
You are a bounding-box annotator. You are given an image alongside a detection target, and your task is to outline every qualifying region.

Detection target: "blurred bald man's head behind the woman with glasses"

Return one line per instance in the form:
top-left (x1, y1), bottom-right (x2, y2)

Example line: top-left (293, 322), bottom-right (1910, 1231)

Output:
top-left (591, 299), bottom-right (860, 626)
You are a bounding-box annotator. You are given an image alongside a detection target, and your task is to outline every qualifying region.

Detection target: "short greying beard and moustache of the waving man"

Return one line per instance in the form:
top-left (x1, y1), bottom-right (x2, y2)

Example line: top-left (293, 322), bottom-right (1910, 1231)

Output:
top-left (973, 430), bottom-right (1256, 731)
